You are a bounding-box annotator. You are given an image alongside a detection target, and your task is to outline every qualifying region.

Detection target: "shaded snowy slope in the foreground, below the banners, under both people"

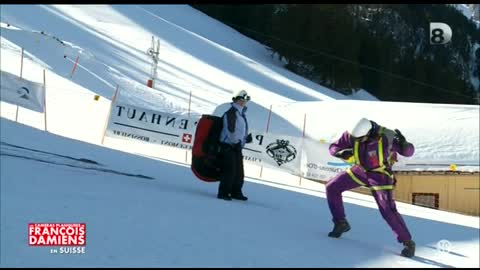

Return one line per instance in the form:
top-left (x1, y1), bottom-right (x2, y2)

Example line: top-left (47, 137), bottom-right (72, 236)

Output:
top-left (0, 119), bottom-right (480, 267)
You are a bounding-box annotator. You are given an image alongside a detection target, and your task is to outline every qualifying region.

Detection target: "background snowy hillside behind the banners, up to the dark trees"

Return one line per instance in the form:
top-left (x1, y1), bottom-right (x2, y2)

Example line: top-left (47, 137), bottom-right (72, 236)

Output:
top-left (1, 5), bottom-right (480, 170)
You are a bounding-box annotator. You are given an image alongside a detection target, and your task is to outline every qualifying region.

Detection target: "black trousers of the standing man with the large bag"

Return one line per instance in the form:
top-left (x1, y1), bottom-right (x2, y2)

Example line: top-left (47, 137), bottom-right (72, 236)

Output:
top-left (218, 144), bottom-right (244, 195)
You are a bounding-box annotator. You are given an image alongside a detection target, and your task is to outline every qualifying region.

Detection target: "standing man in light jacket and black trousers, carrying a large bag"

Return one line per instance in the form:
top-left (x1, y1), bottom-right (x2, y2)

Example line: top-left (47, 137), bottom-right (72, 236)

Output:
top-left (217, 90), bottom-right (252, 201)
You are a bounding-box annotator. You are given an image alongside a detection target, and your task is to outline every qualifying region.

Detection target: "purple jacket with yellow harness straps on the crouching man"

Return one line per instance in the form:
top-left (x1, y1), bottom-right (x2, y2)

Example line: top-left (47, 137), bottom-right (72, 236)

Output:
top-left (329, 126), bottom-right (415, 178)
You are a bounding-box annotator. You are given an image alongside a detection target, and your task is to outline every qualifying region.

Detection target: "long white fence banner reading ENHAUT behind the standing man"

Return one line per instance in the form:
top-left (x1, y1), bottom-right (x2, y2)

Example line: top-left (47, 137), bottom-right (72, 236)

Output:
top-left (102, 91), bottom-right (348, 180)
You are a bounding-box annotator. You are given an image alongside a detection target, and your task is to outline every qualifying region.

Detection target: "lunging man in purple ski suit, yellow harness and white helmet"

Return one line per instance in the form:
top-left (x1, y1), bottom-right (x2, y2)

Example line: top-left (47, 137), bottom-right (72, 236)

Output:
top-left (326, 118), bottom-right (415, 257)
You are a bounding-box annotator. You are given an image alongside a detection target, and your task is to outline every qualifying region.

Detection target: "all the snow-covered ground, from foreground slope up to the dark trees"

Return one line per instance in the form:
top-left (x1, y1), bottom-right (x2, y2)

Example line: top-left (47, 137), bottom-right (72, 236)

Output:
top-left (0, 5), bottom-right (480, 267)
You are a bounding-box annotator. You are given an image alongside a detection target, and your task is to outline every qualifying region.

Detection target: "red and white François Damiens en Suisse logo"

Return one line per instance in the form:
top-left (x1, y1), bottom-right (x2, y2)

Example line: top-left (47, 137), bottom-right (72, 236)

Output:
top-left (28, 223), bottom-right (87, 254)
